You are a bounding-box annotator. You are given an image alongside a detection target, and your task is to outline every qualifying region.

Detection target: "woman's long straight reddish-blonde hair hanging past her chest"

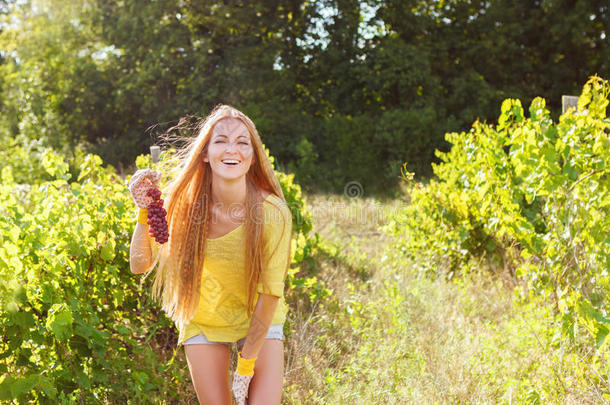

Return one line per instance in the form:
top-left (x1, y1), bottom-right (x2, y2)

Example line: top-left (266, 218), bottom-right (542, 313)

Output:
top-left (152, 105), bottom-right (290, 324)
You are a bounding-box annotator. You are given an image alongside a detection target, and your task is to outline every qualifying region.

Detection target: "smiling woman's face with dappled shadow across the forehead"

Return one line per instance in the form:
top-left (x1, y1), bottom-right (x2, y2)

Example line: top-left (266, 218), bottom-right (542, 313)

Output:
top-left (203, 118), bottom-right (254, 180)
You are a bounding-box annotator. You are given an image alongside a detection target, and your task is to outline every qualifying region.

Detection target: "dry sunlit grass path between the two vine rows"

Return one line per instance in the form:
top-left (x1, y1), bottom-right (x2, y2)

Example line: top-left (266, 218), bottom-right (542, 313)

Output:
top-left (284, 191), bottom-right (603, 404)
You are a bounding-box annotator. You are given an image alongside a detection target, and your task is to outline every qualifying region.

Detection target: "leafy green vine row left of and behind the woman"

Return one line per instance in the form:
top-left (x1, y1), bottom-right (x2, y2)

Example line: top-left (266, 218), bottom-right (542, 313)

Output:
top-left (0, 142), bottom-right (317, 404)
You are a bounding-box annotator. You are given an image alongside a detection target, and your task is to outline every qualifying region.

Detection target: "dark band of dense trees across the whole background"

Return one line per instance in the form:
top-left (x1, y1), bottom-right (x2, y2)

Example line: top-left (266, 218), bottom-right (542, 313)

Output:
top-left (0, 0), bottom-right (610, 192)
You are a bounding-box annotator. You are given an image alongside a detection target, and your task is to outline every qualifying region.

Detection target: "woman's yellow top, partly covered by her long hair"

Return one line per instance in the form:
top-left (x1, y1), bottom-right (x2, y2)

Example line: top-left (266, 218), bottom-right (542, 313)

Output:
top-left (150, 194), bottom-right (292, 345)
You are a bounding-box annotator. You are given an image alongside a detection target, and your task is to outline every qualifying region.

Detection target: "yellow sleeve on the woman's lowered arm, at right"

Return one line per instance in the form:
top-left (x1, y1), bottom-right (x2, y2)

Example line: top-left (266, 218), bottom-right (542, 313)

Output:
top-left (258, 205), bottom-right (292, 297)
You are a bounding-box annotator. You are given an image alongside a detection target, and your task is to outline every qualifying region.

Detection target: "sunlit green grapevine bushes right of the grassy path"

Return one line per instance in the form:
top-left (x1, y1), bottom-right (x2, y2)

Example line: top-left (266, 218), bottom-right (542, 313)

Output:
top-left (387, 77), bottom-right (610, 350)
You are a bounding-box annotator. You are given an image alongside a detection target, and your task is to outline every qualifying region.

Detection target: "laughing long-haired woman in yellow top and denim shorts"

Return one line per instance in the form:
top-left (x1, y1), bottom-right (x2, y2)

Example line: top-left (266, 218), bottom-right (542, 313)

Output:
top-left (129, 105), bottom-right (292, 405)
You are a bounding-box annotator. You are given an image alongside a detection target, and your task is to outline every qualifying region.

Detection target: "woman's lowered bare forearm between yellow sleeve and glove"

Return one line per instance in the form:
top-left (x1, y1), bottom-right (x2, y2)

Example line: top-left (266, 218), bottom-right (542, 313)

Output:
top-left (241, 294), bottom-right (280, 359)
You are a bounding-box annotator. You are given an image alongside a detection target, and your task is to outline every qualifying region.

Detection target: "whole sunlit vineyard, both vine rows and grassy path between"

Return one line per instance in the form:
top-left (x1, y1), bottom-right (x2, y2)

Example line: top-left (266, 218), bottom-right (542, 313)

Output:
top-left (0, 77), bottom-right (610, 404)
